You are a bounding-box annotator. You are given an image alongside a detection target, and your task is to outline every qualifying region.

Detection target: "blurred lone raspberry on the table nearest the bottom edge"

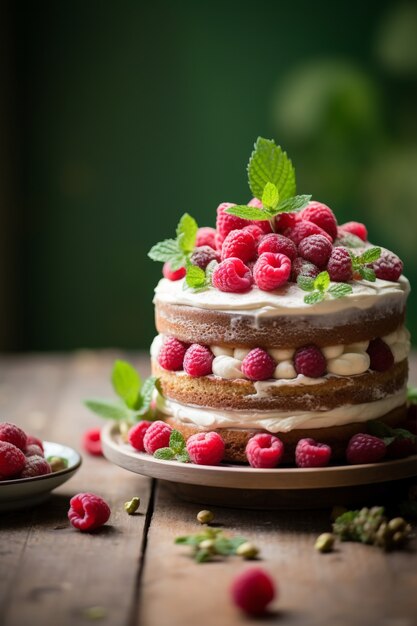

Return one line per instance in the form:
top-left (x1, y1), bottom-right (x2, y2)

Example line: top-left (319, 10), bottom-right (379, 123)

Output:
top-left (230, 567), bottom-right (276, 615)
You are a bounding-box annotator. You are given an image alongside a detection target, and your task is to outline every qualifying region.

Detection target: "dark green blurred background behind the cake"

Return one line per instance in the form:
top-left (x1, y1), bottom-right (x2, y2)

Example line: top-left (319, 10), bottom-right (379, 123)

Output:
top-left (0, 0), bottom-right (417, 350)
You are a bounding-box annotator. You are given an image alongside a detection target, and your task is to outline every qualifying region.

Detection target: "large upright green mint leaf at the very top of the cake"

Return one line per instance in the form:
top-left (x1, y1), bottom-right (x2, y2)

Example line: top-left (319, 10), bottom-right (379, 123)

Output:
top-left (248, 137), bottom-right (296, 200)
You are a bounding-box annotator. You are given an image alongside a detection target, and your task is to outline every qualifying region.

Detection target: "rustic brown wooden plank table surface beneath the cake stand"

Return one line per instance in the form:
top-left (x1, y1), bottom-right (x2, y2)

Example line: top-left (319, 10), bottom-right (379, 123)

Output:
top-left (0, 351), bottom-right (417, 626)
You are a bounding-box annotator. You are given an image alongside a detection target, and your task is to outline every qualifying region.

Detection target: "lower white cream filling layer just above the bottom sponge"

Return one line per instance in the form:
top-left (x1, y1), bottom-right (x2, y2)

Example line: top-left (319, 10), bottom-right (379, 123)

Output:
top-left (158, 387), bottom-right (407, 433)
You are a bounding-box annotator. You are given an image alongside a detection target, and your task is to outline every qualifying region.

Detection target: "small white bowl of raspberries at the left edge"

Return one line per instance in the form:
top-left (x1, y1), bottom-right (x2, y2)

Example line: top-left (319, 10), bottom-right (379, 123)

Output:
top-left (0, 422), bottom-right (81, 511)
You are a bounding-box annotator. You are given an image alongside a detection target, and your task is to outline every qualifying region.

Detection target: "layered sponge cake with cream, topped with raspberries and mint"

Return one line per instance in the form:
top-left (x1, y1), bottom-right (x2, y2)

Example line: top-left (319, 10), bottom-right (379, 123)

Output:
top-left (150, 138), bottom-right (410, 462)
